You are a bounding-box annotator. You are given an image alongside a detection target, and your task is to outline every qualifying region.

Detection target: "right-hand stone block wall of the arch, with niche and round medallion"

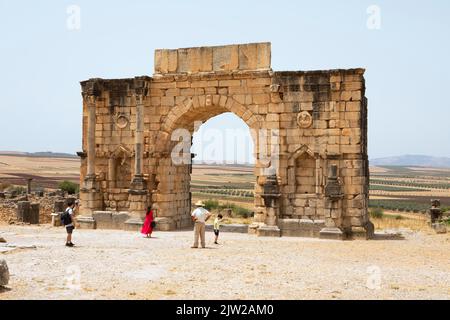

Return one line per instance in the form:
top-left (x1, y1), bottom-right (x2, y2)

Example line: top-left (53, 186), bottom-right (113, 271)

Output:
top-left (272, 69), bottom-right (369, 235)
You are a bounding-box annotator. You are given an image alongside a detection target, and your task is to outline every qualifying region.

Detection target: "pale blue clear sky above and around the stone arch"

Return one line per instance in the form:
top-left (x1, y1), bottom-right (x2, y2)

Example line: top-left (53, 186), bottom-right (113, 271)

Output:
top-left (0, 0), bottom-right (450, 158)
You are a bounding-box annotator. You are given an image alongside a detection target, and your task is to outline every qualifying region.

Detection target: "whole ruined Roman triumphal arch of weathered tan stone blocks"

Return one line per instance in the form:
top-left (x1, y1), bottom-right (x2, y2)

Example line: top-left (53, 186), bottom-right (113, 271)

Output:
top-left (78, 43), bottom-right (373, 239)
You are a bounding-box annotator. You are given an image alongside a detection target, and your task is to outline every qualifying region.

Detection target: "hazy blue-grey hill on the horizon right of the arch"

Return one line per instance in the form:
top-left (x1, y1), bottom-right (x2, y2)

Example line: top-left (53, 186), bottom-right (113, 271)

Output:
top-left (370, 155), bottom-right (450, 168)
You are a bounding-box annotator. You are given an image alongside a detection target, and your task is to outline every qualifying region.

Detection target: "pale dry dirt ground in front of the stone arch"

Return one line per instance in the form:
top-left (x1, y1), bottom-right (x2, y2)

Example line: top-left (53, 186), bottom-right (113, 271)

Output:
top-left (0, 226), bottom-right (450, 299)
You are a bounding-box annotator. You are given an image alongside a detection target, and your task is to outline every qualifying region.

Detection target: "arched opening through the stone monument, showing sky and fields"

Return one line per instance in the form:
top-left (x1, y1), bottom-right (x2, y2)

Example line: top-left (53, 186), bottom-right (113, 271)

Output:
top-left (190, 112), bottom-right (256, 223)
